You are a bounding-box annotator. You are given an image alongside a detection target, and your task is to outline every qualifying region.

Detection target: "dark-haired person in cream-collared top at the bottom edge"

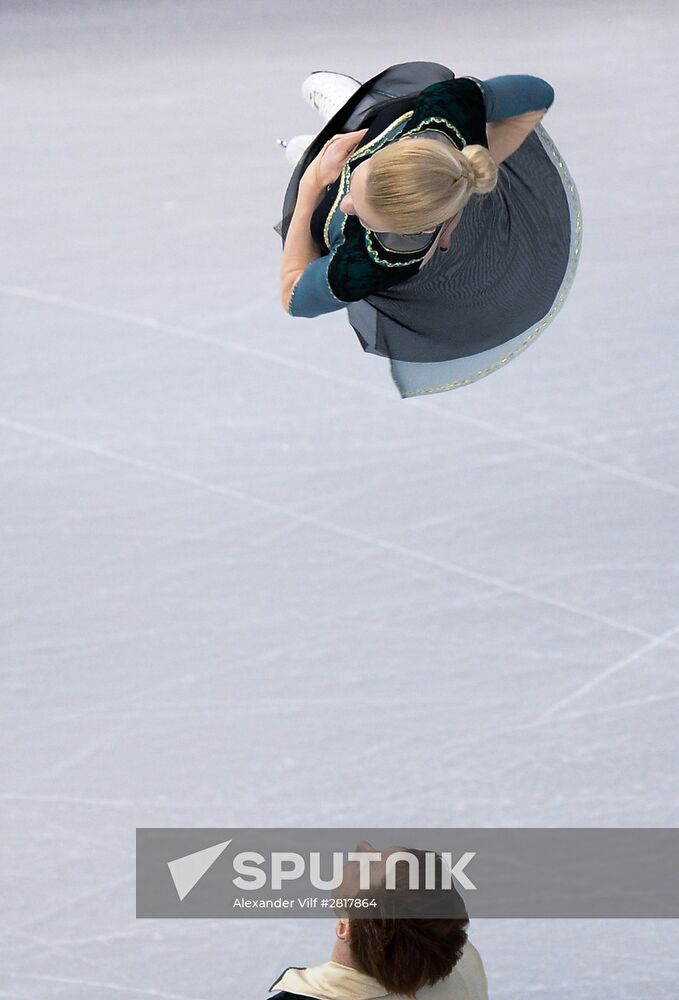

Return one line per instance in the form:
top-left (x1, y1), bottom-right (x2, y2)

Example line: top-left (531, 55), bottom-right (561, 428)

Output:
top-left (271, 842), bottom-right (488, 1000)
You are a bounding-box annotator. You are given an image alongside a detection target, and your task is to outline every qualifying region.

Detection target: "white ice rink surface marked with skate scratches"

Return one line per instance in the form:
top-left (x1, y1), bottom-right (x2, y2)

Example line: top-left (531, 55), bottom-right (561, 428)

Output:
top-left (0, 0), bottom-right (679, 1000)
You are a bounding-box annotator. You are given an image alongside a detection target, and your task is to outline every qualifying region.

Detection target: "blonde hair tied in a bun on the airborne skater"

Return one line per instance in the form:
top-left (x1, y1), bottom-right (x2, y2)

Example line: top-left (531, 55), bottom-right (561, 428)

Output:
top-left (365, 136), bottom-right (497, 234)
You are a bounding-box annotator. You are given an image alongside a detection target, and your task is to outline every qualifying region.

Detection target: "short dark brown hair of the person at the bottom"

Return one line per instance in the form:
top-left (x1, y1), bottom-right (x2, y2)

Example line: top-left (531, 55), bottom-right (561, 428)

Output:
top-left (349, 848), bottom-right (469, 997)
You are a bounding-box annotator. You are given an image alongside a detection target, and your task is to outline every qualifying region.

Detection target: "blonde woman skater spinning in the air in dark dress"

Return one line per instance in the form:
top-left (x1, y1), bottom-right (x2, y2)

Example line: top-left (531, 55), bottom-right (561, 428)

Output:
top-left (274, 62), bottom-right (581, 398)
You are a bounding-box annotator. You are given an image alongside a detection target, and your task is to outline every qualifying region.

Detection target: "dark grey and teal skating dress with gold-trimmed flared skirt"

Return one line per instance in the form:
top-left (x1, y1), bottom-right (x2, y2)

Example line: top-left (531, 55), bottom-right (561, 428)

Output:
top-left (274, 62), bottom-right (582, 397)
